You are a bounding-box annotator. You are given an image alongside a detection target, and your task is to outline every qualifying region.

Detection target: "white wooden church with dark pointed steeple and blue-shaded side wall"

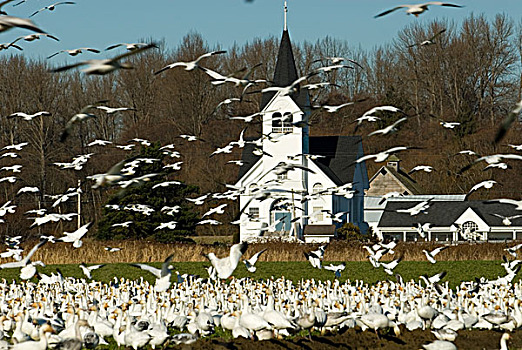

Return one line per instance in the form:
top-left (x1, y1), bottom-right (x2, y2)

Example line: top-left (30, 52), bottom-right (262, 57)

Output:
top-left (236, 28), bottom-right (369, 243)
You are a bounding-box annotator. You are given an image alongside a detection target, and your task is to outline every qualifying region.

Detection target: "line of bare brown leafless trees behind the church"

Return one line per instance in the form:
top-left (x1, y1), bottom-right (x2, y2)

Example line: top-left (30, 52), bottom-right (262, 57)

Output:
top-left (0, 14), bottom-right (522, 238)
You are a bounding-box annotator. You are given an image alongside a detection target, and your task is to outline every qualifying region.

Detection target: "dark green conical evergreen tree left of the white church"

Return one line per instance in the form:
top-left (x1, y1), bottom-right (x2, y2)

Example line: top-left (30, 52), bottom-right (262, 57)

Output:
top-left (97, 143), bottom-right (199, 242)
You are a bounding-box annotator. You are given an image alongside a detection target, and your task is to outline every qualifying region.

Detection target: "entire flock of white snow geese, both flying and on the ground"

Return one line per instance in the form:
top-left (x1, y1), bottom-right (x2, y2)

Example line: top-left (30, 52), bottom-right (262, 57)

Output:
top-left (0, 0), bottom-right (522, 350)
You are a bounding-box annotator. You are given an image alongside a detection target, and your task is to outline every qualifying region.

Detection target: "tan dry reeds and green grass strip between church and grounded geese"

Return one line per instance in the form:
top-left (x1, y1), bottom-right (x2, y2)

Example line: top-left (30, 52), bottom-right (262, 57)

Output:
top-left (0, 241), bottom-right (519, 286)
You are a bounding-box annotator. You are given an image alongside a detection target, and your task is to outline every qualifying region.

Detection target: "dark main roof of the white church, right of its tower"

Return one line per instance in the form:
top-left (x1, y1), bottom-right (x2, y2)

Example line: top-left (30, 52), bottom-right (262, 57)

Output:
top-left (309, 136), bottom-right (361, 185)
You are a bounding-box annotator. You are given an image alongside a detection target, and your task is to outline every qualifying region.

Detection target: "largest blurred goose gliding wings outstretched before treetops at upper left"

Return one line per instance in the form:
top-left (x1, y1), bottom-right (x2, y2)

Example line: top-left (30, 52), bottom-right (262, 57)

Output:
top-left (51, 44), bottom-right (158, 75)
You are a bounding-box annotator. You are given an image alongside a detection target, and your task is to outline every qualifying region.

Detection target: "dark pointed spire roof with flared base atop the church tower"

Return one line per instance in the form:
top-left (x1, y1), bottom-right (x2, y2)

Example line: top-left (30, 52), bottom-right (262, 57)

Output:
top-left (261, 30), bottom-right (310, 110)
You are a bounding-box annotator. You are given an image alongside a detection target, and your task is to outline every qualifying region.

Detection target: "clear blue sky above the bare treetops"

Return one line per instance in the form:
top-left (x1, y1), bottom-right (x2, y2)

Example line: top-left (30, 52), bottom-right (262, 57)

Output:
top-left (0, 0), bottom-right (522, 62)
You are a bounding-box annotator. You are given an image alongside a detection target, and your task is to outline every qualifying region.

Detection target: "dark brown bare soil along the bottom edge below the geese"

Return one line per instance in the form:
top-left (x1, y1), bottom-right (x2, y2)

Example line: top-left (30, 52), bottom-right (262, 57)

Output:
top-left (169, 329), bottom-right (522, 350)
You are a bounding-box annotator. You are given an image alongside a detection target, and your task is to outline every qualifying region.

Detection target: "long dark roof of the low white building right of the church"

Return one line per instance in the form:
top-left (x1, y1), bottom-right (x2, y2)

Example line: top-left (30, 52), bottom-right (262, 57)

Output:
top-left (378, 201), bottom-right (522, 228)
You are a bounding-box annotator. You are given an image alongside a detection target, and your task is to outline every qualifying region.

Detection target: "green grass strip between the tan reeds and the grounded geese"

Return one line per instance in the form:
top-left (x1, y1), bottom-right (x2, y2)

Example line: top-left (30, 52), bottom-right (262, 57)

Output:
top-left (0, 261), bottom-right (520, 287)
